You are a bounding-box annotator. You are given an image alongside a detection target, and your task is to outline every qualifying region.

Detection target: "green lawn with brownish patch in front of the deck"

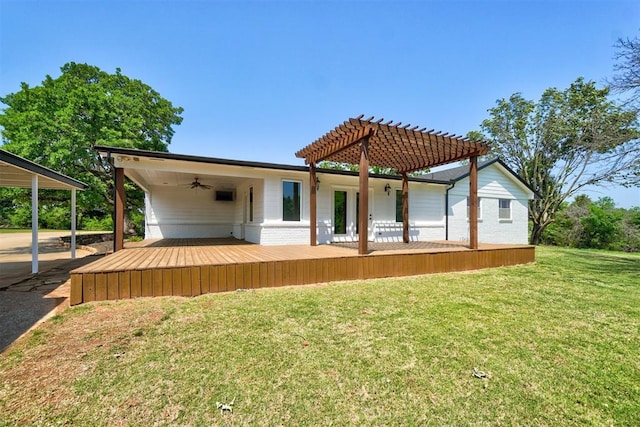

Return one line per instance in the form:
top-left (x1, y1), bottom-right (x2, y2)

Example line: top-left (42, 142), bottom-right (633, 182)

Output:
top-left (0, 247), bottom-right (640, 426)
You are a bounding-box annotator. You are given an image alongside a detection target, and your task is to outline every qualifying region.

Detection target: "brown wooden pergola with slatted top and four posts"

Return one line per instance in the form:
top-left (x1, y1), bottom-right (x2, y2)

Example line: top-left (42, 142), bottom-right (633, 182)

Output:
top-left (296, 115), bottom-right (490, 254)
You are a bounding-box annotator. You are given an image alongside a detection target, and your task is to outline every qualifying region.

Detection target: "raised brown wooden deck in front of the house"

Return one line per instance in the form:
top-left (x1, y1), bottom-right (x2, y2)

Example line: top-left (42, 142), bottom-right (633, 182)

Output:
top-left (70, 239), bottom-right (535, 305)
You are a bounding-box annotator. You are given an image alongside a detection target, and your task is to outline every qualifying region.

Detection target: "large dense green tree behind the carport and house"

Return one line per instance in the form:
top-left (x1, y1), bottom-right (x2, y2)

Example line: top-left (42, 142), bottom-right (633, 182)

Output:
top-left (0, 62), bottom-right (183, 232)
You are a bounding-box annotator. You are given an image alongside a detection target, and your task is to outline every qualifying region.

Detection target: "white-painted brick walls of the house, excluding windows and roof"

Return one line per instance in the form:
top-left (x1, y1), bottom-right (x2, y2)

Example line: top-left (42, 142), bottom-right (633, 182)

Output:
top-left (146, 164), bottom-right (530, 245)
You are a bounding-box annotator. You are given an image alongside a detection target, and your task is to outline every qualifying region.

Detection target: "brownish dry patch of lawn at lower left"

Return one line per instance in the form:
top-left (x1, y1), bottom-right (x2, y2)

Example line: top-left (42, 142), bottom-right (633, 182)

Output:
top-left (0, 299), bottom-right (166, 424)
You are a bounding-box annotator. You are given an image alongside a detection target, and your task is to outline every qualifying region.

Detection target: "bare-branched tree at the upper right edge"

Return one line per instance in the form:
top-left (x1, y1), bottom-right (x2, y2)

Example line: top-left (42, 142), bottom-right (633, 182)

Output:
top-left (608, 33), bottom-right (640, 111)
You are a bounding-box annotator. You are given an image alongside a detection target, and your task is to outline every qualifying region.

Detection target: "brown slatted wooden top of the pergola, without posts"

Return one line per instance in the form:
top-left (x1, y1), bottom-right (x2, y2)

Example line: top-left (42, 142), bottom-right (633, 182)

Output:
top-left (296, 115), bottom-right (490, 173)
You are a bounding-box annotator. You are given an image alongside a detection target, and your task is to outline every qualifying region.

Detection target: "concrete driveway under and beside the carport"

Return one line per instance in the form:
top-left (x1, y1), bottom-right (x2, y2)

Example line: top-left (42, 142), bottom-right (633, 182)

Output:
top-left (0, 231), bottom-right (95, 352)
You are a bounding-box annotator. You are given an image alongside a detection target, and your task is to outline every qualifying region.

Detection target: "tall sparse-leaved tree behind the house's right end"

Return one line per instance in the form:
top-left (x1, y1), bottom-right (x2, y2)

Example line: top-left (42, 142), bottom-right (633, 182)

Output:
top-left (481, 78), bottom-right (640, 244)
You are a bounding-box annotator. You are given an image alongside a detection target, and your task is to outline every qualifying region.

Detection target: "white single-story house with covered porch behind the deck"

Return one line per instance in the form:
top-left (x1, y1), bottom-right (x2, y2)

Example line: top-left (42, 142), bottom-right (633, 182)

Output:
top-left (97, 147), bottom-right (534, 245)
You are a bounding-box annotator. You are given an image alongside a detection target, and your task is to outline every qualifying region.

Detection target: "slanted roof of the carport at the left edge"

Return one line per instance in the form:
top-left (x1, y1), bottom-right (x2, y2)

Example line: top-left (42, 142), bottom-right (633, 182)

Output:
top-left (0, 149), bottom-right (89, 190)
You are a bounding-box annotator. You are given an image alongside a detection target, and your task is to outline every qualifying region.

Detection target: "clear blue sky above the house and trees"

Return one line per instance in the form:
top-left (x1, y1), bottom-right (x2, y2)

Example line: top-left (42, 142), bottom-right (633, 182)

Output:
top-left (0, 0), bottom-right (640, 208)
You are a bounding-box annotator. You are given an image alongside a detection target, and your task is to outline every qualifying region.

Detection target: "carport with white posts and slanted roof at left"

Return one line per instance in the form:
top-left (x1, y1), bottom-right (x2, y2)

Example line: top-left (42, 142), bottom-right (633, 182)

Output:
top-left (0, 149), bottom-right (88, 274)
